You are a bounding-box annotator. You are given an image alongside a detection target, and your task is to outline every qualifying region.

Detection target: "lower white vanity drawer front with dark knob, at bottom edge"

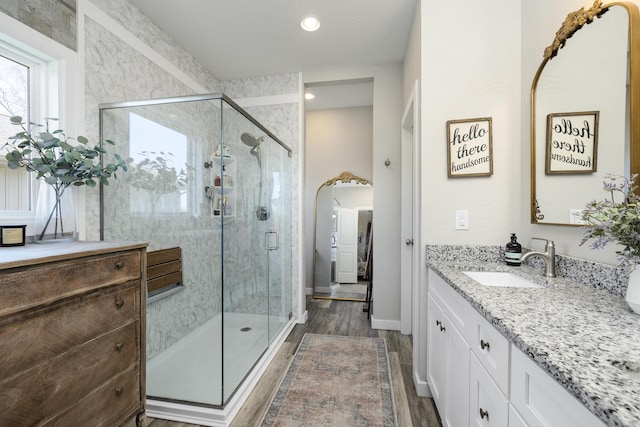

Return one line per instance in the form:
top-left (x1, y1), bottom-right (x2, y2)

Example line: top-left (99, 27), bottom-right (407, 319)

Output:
top-left (468, 353), bottom-right (509, 427)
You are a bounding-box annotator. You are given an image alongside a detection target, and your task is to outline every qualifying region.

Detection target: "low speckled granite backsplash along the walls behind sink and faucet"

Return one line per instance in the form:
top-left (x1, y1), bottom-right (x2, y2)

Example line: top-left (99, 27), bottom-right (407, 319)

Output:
top-left (426, 245), bottom-right (629, 297)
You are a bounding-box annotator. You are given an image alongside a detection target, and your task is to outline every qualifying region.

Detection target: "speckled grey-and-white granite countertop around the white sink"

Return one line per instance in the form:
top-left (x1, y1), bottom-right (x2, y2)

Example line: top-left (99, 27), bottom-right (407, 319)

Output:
top-left (428, 261), bottom-right (640, 426)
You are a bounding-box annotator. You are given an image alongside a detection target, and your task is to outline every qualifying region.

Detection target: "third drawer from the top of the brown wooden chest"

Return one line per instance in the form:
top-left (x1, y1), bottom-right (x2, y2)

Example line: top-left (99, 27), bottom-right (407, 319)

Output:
top-left (0, 321), bottom-right (140, 425)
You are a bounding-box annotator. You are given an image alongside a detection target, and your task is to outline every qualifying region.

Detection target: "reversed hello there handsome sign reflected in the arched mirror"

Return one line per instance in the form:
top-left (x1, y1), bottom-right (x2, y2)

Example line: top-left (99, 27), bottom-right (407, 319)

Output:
top-left (545, 111), bottom-right (600, 174)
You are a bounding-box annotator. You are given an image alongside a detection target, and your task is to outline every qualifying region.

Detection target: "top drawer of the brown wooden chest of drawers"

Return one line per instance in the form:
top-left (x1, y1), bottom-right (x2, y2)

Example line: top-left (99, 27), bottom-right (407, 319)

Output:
top-left (0, 251), bottom-right (141, 318)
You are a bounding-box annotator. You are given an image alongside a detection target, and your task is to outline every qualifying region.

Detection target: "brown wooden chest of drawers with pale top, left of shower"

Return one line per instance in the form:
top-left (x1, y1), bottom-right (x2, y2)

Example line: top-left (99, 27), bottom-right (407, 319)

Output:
top-left (0, 242), bottom-right (146, 427)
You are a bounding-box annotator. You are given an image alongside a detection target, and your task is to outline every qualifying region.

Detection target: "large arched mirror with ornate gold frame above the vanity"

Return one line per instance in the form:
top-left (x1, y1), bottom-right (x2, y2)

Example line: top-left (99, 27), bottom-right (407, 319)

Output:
top-left (531, 0), bottom-right (640, 225)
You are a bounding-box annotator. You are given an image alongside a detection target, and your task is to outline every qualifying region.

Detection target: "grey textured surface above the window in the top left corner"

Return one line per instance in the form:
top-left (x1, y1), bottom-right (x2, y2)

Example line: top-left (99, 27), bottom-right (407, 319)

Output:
top-left (0, 0), bottom-right (77, 51)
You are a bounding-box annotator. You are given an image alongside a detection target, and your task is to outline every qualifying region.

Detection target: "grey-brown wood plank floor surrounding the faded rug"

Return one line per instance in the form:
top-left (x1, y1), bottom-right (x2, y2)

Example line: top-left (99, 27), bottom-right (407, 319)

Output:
top-left (144, 299), bottom-right (441, 427)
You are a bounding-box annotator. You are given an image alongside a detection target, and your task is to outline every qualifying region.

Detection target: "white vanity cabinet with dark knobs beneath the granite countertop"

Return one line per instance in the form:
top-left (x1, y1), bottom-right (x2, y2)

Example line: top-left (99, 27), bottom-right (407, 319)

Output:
top-left (427, 269), bottom-right (604, 427)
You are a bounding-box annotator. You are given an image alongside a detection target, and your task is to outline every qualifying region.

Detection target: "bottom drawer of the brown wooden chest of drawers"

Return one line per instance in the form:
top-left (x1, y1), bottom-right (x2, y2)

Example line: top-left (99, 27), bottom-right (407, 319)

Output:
top-left (43, 365), bottom-right (140, 427)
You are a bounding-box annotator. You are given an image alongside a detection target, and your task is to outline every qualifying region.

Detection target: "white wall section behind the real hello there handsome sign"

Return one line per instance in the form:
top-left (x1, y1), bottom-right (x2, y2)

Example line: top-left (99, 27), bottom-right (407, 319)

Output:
top-left (421, 0), bottom-right (524, 245)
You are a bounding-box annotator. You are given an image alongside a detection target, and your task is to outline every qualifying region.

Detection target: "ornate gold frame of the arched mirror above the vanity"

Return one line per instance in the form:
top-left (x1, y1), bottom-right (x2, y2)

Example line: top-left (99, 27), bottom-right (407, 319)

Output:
top-left (530, 0), bottom-right (640, 226)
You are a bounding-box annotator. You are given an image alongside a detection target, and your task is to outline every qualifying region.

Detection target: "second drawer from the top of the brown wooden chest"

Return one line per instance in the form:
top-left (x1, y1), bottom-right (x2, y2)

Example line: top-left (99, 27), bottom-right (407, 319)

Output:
top-left (0, 283), bottom-right (140, 379)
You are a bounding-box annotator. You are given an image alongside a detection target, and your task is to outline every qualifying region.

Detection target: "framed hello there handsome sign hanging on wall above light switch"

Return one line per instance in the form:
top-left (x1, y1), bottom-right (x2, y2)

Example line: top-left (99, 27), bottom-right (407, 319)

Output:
top-left (447, 117), bottom-right (493, 178)
